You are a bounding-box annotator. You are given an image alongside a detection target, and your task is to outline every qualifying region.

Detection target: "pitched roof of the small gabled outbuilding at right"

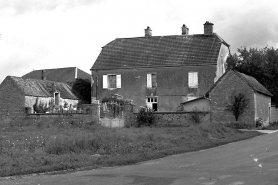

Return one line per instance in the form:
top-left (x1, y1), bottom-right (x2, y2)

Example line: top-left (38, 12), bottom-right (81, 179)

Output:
top-left (206, 70), bottom-right (272, 96)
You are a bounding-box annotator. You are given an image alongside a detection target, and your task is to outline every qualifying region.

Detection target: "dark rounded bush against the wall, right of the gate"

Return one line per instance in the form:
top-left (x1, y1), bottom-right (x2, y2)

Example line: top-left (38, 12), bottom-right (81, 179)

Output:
top-left (137, 107), bottom-right (155, 127)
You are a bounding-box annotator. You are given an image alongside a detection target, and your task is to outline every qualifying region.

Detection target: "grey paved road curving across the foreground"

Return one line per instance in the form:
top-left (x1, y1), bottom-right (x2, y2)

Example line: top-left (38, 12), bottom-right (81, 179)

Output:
top-left (0, 132), bottom-right (278, 185)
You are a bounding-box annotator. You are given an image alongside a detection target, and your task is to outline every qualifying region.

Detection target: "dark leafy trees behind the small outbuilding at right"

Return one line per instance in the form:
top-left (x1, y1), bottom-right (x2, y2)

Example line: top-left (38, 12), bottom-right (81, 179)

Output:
top-left (227, 47), bottom-right (278, 106)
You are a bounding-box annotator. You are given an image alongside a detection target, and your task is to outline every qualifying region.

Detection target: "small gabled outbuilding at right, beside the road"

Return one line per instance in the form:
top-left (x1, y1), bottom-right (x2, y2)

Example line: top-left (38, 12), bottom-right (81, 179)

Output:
top-left (206, 70), bottom-right (272, 126)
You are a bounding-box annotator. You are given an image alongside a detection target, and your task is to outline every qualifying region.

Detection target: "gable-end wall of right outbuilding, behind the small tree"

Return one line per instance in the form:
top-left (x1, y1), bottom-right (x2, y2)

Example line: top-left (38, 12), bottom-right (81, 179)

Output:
top-left (209, 73), bottom-right (255, 126)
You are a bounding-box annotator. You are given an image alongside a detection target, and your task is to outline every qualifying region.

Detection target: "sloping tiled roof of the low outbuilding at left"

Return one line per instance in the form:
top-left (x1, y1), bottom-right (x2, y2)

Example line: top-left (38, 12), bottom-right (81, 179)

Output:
top-left (7, 76), bottom-right (78, 100)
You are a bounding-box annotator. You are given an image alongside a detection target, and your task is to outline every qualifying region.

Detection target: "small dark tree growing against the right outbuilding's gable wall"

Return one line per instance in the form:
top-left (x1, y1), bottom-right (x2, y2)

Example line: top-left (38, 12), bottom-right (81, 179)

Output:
top-left (226, 93), bottom-right (249, 121)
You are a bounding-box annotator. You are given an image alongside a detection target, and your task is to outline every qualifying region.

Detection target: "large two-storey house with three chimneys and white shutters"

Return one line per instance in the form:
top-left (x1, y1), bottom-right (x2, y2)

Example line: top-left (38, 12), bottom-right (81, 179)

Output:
top-left (91, 22), bottom-right (229, 112)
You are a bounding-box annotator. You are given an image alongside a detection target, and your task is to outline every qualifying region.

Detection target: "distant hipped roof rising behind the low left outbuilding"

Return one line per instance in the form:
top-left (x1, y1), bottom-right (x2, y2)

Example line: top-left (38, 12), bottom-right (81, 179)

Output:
top-left (22, 67), bottom-right (91, 82)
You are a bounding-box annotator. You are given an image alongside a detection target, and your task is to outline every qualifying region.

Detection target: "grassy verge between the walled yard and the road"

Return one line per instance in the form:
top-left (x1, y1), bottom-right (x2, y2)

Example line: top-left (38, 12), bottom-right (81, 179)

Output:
top-left (0, 120), bottom-right (259, 176)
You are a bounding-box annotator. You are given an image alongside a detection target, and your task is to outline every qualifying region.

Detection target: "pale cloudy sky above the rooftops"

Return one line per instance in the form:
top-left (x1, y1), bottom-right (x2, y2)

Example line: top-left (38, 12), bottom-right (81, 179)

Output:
top-left (0, 0), bottom-right (278, 83)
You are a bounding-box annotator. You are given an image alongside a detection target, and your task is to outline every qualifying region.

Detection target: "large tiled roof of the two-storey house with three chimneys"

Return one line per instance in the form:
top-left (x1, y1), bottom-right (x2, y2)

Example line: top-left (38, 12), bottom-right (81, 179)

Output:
top-left (92, 33), bottom-right (229, 70)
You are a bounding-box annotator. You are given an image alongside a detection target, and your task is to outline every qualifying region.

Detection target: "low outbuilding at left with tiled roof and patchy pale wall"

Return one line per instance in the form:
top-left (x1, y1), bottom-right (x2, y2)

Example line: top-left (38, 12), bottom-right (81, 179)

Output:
top-left (0, 76), bottom-right (81, 120)
